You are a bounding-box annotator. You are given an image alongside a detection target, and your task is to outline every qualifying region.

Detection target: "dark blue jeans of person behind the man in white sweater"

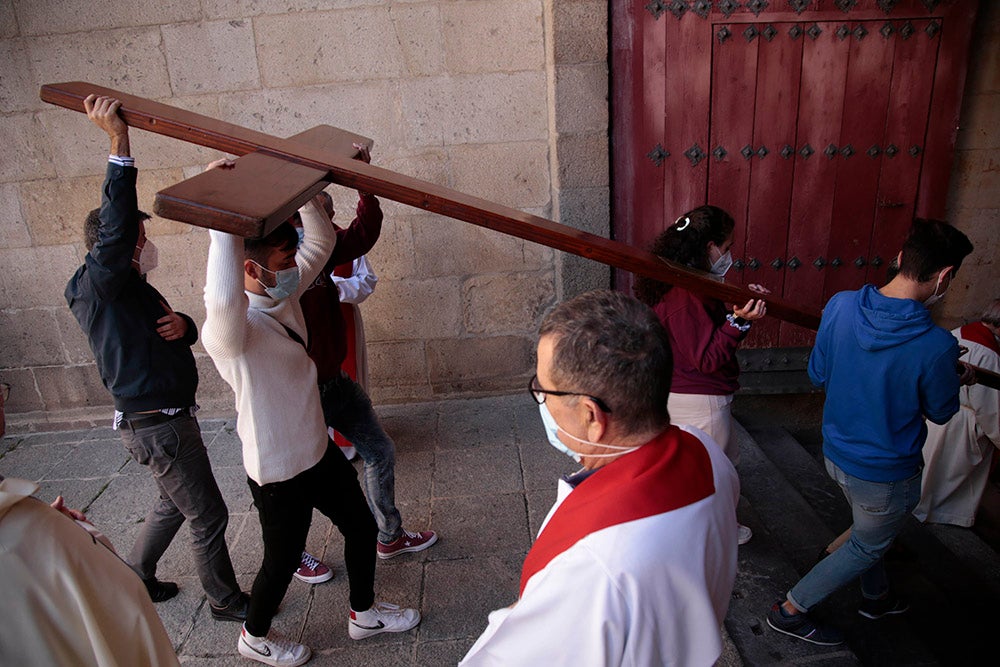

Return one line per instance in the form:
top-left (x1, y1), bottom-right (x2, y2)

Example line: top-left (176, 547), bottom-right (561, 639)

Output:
top-left (319, 371), bottom-right (403, 544)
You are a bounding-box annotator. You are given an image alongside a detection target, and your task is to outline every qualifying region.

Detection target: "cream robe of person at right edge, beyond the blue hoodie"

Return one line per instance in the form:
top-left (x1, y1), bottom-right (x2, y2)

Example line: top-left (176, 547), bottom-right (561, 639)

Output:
top-left (913, 327), bottom-right (1000, 527)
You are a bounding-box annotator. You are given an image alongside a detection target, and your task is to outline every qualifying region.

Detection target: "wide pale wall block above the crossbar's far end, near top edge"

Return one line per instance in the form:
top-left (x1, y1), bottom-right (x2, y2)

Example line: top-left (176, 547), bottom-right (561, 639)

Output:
top-left (254, 7), bottom-right (405, 88)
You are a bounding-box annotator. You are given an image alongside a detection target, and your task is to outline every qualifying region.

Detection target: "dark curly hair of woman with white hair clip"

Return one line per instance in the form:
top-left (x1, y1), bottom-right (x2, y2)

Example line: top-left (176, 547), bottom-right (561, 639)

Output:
top-left (634, 205), bottom-right (736, 307)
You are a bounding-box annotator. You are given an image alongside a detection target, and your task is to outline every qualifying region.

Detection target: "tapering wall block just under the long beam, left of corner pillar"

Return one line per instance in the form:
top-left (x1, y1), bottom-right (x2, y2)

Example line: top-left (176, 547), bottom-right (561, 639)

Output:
top-left (413, 216), bottom-right (552, 277)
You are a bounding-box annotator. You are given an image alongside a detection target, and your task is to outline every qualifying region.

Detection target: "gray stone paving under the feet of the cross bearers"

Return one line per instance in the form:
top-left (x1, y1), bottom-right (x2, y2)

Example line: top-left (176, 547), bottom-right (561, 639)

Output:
top-left (0, 394), bottom-right (573, 667)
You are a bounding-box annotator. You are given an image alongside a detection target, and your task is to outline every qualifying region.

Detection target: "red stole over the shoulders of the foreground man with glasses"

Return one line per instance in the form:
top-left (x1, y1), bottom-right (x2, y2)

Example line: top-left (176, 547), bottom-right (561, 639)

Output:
top-left (518, 426), bottom-right (715, 596)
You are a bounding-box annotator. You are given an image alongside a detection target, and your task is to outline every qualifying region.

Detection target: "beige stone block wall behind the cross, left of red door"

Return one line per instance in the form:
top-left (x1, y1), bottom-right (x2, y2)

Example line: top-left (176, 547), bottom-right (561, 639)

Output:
top-left (0, 0), bottom-right (609, 428)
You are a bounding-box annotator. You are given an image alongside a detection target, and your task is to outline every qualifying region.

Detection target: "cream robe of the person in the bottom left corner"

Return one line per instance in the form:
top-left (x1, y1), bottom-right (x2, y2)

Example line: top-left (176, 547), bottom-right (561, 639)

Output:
top-left (0, 478), bottom-right (179, 667)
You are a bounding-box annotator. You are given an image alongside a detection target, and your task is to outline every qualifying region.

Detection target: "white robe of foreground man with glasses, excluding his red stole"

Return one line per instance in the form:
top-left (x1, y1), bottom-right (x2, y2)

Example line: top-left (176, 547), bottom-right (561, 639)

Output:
top-left (460, 428), bottom-right (739, 667)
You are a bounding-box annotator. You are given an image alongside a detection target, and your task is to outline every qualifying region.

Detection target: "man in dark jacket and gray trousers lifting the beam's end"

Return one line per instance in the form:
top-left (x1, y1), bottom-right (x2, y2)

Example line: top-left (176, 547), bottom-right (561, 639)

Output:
top-left (65, 95), bottom-right (247, 621)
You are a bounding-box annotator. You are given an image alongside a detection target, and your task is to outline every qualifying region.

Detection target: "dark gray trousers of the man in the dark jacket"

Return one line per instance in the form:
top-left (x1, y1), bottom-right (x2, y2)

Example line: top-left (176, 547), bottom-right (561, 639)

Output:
top-left (120, 415), bottom-right (240, 606)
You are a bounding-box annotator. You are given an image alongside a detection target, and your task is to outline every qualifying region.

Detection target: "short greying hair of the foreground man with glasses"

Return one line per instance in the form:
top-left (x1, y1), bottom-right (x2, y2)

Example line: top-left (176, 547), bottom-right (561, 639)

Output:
top-left (539, 290), bottom-right (673, 434)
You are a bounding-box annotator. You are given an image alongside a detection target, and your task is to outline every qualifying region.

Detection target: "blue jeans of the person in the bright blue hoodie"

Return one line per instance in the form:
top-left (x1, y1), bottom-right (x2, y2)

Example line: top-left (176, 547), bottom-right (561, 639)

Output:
top-left (788, 459), bottom-right (920, 612)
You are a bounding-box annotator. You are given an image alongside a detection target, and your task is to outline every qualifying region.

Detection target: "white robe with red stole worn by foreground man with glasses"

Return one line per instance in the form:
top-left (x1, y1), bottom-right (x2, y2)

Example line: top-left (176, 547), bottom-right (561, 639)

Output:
top-left (460, 426), bottom-right (739, 667)
